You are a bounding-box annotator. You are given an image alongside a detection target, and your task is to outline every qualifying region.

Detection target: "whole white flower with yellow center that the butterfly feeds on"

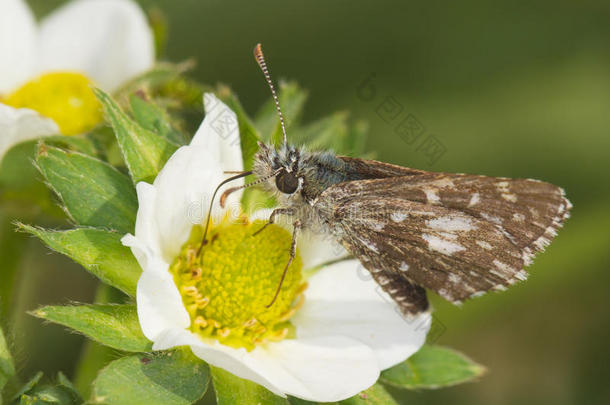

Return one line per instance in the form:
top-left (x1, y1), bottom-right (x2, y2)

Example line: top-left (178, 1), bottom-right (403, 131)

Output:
top-left (122, 94), bottom-right (431, 402)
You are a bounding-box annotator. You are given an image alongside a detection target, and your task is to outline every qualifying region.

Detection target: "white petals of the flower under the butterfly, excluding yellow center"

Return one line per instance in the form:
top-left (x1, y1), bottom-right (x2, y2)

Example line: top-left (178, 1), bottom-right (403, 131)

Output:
top-left (122, 94), bottom-right (430, 402)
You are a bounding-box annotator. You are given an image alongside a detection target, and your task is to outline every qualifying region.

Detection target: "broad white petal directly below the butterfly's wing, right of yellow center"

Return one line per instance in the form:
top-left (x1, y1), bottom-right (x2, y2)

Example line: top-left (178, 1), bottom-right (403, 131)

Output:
top-left (292, 260), bottom-right (431, 370)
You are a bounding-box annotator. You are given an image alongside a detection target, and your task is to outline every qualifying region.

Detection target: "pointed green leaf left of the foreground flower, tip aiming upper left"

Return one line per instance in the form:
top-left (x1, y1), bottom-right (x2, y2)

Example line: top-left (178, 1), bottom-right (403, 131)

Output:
top-left (17, 224), bottom-right (142, 297)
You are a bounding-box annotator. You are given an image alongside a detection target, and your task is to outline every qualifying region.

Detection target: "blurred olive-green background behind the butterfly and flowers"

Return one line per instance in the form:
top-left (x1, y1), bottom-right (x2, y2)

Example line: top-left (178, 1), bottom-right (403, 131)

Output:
top-left (0, 0), bottom-right (610, 404)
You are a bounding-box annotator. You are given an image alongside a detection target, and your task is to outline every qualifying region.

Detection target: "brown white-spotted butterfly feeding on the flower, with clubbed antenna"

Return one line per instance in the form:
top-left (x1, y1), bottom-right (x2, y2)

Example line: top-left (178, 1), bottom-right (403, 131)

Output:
top-left (205, 44), bottom-right (572, 315)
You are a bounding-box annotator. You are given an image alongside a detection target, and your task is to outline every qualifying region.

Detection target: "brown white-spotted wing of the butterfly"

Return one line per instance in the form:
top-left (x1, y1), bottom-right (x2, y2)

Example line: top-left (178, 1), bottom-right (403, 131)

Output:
top-left (316, 161), bottom-right (570, 313)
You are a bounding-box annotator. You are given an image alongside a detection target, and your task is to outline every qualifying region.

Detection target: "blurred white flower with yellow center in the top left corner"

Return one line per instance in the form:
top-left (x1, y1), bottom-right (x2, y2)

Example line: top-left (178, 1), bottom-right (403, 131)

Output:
top-left (0, 0), bottom-right (154, 159)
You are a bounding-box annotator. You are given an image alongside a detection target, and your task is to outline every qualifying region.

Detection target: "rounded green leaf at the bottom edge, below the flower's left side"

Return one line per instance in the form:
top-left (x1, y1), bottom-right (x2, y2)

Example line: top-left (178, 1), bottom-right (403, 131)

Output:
top-left (90, 350), bottom-right (210, 405)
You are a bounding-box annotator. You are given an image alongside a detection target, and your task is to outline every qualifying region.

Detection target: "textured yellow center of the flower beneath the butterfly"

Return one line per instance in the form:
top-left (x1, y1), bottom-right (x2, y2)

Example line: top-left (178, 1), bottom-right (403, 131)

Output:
top-left (170, 221), bottom-right (306, 350)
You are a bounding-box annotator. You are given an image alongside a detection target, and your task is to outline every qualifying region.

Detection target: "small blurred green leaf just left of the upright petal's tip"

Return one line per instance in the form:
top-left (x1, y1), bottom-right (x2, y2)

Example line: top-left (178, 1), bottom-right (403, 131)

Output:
top-left (129, 94), bottom-right (185, 145)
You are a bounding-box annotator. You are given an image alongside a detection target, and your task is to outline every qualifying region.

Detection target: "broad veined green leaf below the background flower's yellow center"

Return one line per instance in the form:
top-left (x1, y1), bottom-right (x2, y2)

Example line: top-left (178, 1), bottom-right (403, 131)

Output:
top-left (36, 143), bottom-right (138, 232)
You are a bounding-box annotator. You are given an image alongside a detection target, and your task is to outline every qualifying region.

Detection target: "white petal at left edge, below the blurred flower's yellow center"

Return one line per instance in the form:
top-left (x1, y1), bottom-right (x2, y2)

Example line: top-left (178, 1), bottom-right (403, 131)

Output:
top-left (0, 103), bottom-right (59, 159)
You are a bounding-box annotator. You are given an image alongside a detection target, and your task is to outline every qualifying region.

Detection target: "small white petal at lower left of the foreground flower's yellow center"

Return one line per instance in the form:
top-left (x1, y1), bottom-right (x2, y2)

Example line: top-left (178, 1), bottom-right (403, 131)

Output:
top-left (136, 268), bottom-right (191, 342)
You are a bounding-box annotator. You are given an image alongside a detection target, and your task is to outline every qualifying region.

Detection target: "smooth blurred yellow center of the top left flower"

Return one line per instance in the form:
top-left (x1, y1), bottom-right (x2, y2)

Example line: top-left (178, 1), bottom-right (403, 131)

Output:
top-left (2, 72), bottom-right (102, 135)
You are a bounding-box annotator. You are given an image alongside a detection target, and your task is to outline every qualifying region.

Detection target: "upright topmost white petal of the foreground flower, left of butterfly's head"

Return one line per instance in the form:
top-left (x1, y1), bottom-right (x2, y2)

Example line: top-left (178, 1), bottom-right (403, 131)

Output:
top-left (191, 93), bottom-right (244, 210)
